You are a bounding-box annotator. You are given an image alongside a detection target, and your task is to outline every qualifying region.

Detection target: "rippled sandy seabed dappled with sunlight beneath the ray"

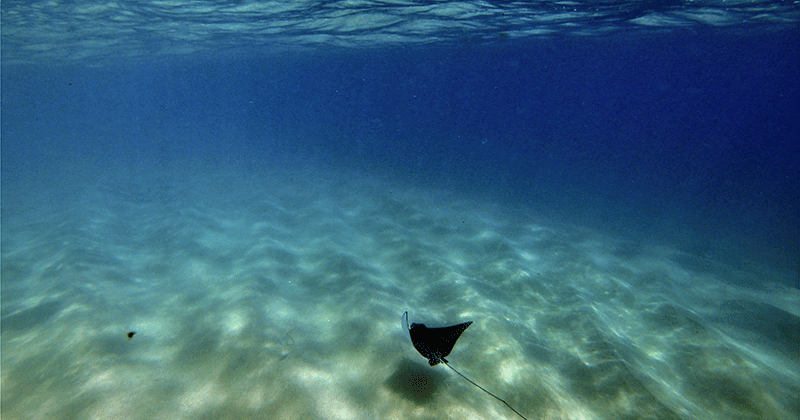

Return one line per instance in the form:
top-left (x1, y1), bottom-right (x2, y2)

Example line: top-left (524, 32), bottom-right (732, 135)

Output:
top-left (0, 162), bottom-right (800, 420)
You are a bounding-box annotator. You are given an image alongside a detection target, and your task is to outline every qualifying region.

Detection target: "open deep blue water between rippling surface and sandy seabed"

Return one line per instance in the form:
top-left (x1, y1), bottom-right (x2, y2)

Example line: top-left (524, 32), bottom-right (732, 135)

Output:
top-left (2, 29), bottom-right (800, 271)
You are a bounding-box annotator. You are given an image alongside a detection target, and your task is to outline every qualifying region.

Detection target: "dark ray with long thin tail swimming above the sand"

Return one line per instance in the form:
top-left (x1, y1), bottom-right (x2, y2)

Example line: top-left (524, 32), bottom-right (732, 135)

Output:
top-left (403, 311), bottom-right (528, 420)
